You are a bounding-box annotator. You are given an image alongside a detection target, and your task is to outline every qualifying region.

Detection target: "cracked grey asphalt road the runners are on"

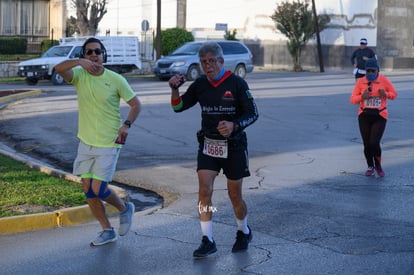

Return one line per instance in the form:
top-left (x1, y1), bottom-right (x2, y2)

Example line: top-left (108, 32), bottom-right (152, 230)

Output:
top-left (0, 72), bottom-right (414, 274)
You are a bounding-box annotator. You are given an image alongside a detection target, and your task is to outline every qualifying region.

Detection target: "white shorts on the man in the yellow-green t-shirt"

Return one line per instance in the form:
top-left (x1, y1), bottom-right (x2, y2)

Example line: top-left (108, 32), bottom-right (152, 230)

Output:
top-left (73, 141), bottom-right (121, 182)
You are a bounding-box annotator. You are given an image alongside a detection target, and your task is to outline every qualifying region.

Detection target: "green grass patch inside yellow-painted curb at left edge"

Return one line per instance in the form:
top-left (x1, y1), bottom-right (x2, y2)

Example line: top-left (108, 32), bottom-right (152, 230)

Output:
top-left (0, 155), bottom-right (86, 218)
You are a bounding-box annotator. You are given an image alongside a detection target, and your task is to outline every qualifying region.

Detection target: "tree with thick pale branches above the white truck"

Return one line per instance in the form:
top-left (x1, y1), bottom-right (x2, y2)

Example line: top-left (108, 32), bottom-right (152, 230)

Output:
top-left (66, 0), bottom-right (108, 36)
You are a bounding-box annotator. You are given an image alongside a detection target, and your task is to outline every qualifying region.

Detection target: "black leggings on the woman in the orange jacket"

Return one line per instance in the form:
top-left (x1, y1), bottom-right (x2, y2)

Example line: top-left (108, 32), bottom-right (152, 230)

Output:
top-left (358, 114), bottom-right (387, 167)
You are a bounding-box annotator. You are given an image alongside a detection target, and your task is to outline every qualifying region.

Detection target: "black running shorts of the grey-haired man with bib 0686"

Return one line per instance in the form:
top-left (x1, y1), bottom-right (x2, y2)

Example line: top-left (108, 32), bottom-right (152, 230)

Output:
top-left (197, 149), bottom-right (250, 180)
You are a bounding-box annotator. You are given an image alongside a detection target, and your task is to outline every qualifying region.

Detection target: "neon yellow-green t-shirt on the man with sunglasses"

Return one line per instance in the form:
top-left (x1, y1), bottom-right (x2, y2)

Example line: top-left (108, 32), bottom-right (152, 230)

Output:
top-left (72, 67), bottom-right (136, 147)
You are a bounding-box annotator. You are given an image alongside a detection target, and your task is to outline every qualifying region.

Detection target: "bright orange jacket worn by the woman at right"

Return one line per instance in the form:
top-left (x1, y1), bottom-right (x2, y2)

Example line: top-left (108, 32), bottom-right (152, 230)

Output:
top-left (350, 74), bottom-right (397, 119)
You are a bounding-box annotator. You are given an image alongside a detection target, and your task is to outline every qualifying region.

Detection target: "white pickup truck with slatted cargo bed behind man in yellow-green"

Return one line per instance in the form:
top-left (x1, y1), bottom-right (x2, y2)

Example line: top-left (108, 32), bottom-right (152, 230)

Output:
top-left (17, 36), bottom-right (141, 85)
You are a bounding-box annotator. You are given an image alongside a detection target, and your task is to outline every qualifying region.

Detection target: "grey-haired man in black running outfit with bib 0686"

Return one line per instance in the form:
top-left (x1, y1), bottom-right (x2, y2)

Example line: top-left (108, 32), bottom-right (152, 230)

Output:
top-left (169, 42), bottom-right (259, 257)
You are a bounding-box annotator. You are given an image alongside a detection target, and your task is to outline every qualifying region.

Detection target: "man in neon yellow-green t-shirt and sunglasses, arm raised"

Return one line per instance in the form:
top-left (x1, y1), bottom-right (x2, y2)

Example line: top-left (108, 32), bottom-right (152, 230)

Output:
top-left (55, 37), bottom-right (141, 246)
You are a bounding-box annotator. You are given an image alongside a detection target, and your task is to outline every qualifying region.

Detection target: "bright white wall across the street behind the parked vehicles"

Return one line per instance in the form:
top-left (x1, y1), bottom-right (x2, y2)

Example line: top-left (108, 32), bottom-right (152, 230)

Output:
top-left (94, 0), bottom-right (377, 46)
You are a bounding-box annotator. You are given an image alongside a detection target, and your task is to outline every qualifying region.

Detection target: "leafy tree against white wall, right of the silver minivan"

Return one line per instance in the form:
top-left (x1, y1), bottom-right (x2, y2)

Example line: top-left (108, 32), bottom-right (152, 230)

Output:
top-left (270, 0), bottom-right (330, 72)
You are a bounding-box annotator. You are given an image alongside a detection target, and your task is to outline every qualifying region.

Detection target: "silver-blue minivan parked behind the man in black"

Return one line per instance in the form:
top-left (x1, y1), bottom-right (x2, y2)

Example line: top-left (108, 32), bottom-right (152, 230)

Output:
top-left (153, 40), bottom-right (253, 80)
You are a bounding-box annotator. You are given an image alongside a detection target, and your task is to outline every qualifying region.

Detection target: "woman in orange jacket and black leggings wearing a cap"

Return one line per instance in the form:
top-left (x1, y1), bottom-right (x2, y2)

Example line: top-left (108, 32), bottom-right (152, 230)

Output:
top-left (350, 58), bottom-right (397, 177)
